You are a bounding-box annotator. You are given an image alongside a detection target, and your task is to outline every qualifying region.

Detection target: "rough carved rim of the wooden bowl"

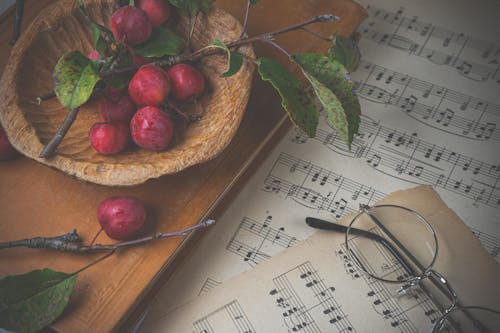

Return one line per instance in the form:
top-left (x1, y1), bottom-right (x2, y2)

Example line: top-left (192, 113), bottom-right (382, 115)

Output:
top-left (0, 0), bottom-right (254, 186)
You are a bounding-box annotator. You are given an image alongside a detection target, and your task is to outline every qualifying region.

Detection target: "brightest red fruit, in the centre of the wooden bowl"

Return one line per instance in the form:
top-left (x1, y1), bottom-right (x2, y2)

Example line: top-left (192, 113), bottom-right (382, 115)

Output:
top-left (128, 65), bottom-right (170, 106)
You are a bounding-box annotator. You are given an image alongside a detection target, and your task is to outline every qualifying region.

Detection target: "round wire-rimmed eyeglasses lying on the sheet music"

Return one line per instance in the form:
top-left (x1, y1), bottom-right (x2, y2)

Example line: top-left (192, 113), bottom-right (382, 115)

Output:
top-left (306, 205), bottom-right (500, 333)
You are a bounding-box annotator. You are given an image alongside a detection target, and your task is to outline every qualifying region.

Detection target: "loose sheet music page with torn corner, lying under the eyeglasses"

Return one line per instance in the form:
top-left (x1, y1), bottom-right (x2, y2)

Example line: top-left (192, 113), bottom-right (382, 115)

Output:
top-left (140, 186), bottom-right (500, 333)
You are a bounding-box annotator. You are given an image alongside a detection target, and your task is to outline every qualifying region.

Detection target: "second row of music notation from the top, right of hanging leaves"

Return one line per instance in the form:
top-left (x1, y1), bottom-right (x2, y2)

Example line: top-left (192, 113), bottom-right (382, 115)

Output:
top-left (353, 61), bottom-right (500, 141)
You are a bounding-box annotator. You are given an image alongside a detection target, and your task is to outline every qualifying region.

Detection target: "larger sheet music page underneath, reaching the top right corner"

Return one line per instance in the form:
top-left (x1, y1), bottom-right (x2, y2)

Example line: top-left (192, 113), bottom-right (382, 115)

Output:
top-left (138, 0), bottom-right (500, 322)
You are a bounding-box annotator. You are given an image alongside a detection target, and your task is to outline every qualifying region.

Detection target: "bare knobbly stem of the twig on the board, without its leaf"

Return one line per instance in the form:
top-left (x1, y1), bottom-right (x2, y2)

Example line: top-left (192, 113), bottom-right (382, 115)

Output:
top-left (0, 220), bottom-right (215, 254)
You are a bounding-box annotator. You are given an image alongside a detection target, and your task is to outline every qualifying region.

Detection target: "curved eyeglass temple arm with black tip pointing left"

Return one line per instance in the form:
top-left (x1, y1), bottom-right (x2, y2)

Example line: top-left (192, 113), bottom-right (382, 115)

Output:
top-left (306, 217), bottom-right (416, 275)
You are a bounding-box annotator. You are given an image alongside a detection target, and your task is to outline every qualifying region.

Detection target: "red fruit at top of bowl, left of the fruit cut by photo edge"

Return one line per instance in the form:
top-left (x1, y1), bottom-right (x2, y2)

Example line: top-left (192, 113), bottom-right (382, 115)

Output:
top-left (109, 6), bottom-right (153, 46)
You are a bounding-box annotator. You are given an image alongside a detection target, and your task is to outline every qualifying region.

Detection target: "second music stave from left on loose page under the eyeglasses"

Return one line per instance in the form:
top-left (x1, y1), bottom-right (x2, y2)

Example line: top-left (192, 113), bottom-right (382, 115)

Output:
top-left (269, 261), bottom-right (356, 333)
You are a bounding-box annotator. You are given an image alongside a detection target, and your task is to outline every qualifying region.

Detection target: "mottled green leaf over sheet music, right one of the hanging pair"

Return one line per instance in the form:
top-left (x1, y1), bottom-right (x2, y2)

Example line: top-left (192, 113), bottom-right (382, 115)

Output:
top-left (292, 54), bottom-right (361, 147)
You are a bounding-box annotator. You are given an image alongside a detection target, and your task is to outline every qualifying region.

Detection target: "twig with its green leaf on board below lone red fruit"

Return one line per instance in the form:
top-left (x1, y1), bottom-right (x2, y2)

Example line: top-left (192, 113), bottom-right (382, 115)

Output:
top-left (0, 220), bottom-right (214, 332)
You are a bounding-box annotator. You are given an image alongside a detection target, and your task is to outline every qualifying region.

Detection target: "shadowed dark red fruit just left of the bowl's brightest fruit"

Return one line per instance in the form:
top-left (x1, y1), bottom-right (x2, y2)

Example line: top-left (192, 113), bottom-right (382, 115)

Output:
top-left (98, 89), bottom-right (136, 124)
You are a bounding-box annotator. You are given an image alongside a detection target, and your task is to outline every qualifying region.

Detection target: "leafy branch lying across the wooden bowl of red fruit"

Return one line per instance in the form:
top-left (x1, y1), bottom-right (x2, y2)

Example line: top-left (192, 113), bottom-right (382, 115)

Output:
top-left (38, 8), bottom-right (358, 158)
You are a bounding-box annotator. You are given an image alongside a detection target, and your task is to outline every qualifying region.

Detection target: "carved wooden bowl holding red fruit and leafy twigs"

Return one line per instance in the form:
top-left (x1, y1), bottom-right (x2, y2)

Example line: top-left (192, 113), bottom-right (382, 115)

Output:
top-left (0, 0), bottom-right (254, 185)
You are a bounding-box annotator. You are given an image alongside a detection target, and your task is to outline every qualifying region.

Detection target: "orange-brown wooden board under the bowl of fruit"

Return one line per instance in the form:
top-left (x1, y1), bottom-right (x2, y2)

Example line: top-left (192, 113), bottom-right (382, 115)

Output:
top-left (0, 0), bottom-right (365, 332)
